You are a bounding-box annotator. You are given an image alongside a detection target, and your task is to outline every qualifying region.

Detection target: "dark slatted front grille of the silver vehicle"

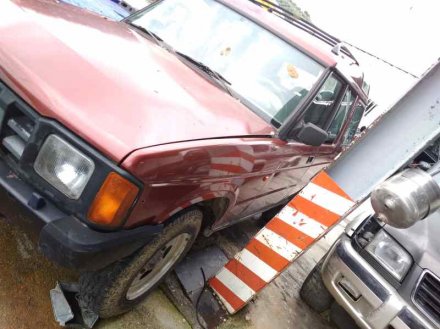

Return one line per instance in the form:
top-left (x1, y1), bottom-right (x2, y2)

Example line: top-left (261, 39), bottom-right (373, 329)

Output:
top-left (414, 272), bottom-right (440, 323)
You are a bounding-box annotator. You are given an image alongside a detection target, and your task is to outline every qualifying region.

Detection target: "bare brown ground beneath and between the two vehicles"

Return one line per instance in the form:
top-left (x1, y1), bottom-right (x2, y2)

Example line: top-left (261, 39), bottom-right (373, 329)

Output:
top-left (0, 190), bottom-right (340, 329)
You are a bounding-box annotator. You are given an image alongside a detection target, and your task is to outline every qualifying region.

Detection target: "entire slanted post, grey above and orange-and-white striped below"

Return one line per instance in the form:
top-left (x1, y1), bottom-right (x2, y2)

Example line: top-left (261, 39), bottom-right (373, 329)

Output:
top-left (209, 62), bottom-right (440, 314)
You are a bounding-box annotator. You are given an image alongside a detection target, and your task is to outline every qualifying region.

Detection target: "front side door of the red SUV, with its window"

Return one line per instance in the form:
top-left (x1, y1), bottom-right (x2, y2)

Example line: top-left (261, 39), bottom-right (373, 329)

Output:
top-left (232, 74), bottom-right (346, 216)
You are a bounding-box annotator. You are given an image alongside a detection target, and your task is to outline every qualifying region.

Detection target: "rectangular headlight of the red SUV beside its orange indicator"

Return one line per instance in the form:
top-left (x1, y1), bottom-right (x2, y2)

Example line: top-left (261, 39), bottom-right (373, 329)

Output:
top-left (34, 135), bottom-right (95, 200)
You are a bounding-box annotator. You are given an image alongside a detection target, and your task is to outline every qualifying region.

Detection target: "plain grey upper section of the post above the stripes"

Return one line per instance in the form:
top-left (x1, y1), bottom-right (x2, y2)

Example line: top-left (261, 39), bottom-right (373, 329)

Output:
top-left (327, 62), bottom-right (440, 201)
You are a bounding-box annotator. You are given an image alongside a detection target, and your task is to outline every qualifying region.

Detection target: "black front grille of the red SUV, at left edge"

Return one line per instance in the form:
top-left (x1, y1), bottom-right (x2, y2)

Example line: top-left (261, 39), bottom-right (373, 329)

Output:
top-left (0, 83), bottom-right (35, 160)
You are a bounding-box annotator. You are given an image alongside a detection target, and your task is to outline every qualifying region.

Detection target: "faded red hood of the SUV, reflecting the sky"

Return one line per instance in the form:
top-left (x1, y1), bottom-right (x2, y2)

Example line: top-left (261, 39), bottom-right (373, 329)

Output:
top-left (0, 0), bottom-right (273, 161)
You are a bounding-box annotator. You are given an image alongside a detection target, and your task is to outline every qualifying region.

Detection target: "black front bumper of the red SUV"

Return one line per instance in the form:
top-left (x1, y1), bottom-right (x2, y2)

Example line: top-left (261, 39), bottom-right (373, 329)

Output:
top-left (0, 158), bottom-right (162, 271)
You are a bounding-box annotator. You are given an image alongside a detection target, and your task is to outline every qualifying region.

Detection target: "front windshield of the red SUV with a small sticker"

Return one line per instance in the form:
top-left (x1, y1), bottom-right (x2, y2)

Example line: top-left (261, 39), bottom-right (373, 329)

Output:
top-left (130, 0), bottom-right (324, 127)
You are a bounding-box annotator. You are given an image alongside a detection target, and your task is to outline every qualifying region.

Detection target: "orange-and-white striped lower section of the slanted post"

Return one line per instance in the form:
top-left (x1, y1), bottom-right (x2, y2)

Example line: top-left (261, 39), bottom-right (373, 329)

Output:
top-left (209, 171), bottom-right (354, 314)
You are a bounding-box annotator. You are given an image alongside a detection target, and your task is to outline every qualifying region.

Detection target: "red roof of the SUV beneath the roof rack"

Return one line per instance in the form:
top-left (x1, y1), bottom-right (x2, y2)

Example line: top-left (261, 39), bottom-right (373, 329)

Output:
top-left (216, 0), bottom-right (368, 102)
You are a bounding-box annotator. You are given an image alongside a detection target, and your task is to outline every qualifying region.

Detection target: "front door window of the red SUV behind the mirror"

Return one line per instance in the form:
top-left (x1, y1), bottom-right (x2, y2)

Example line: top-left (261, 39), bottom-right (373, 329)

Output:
top-left (304, 74), bottom-right (344, 129)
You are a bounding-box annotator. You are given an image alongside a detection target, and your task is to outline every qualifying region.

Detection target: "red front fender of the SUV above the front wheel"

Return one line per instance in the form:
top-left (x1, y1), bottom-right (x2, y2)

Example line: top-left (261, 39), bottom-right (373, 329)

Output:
top-left (122, 138), bottom-right (279, 227)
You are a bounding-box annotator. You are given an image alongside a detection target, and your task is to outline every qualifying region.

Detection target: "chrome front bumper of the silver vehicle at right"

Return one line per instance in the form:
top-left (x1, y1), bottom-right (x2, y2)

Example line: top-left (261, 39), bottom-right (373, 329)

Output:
top-left (321, 235), bottom-right (434, 329)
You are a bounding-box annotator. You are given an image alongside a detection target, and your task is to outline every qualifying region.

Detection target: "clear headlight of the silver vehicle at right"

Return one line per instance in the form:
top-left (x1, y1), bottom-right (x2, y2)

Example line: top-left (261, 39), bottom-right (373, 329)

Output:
top-left (366, 230), bottom-right (412, 281)
